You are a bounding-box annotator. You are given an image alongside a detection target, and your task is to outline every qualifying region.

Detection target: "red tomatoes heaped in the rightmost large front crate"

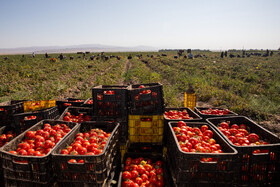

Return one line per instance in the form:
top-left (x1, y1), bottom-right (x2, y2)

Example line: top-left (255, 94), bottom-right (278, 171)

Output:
top-left (218, 122), bottom-right (269, 150)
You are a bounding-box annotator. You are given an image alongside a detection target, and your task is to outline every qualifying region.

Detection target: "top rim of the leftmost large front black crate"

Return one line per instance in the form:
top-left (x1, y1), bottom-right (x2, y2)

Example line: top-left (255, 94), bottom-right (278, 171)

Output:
top-left (0, 119), bottom-right (78, 159)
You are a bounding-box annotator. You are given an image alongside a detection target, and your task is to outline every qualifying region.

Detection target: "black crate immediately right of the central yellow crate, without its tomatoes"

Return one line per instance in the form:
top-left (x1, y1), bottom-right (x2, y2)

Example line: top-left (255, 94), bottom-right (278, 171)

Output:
top-left (163, 108), bottom-right (202, 145)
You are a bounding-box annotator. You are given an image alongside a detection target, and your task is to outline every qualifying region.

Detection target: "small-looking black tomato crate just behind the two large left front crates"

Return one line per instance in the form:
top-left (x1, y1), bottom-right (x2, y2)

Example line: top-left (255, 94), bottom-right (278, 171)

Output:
top-left (59, 107), bottom-right (93, 123)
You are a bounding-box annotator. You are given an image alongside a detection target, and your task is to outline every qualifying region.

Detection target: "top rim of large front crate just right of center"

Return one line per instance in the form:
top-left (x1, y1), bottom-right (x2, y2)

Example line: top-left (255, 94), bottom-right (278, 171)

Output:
top-left (168, 121), bottom-right (238, 157)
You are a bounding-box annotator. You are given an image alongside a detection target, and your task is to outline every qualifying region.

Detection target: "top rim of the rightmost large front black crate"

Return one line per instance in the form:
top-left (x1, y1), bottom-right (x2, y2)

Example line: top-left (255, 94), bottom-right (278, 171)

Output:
top-left (206, 116), bottom-right (280, 148)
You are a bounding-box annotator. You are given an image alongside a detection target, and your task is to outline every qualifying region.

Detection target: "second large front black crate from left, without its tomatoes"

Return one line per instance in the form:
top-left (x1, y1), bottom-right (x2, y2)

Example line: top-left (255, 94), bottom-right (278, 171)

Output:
top-left (52, 122), bottom-right (119, 186)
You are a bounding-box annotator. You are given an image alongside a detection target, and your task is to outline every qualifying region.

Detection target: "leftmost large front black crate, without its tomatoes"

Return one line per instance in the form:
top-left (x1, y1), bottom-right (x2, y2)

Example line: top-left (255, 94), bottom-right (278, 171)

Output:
top-left (0, 120), bottom-right (77, 186)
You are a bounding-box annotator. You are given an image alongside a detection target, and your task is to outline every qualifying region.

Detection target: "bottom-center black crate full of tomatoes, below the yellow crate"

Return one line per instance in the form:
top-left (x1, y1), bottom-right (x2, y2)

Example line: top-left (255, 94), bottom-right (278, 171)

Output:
top-left (118, 153), bottom-right (172, 187)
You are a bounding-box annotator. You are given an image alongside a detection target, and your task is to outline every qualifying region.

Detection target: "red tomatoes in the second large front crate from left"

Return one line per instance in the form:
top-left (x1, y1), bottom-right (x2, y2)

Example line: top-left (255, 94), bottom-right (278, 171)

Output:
top-left (60, 128), bottom-right (111, 163)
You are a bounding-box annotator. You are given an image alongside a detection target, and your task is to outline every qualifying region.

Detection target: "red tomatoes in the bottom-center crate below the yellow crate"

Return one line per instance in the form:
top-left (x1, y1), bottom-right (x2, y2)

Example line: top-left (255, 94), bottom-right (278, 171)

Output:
top-left (122, 157), bottom-right (164, 187)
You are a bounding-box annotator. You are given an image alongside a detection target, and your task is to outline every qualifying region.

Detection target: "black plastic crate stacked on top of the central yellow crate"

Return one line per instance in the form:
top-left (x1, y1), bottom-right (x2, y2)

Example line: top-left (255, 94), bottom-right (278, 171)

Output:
top-left (128, 83), bottom-right (164, 115)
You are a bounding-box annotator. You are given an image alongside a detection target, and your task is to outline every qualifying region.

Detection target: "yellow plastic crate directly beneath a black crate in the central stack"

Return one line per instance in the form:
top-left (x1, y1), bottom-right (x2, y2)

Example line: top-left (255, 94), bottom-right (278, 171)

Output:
top-left (128, 115), bottom-right (164, 144)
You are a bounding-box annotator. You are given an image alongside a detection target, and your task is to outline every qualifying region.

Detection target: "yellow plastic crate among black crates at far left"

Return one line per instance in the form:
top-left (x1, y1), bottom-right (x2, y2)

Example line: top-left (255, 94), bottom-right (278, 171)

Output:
top-left (23, 100), bottom-right (56, 112)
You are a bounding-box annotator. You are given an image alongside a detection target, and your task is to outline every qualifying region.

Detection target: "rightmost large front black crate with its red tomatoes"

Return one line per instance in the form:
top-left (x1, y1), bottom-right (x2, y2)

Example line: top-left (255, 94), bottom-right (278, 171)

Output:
top-left (207, 116), bottom-right (280, 186)
